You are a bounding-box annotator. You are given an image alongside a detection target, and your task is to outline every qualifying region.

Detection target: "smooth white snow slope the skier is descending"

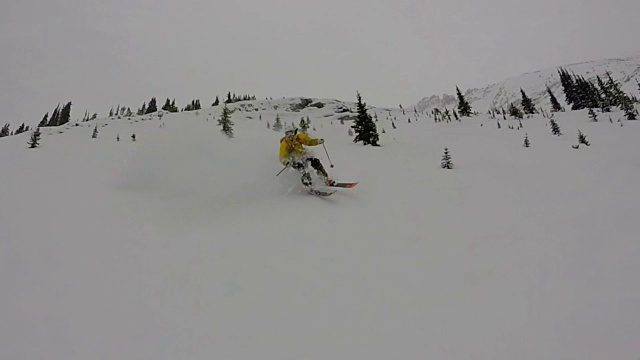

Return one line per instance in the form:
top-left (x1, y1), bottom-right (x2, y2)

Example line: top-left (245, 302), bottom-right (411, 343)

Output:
top-left (0, 99), bottom-right (640, 360)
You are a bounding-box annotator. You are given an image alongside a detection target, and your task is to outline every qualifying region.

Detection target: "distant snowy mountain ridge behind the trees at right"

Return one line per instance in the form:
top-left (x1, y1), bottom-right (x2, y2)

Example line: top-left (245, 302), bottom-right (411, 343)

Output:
top-left (416, 55), bottom-right (640, 113)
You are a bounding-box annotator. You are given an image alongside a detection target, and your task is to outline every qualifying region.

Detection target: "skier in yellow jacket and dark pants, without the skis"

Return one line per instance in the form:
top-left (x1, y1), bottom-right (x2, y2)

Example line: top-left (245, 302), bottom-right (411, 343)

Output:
top-left (280, 126), bottom-right (335, 187)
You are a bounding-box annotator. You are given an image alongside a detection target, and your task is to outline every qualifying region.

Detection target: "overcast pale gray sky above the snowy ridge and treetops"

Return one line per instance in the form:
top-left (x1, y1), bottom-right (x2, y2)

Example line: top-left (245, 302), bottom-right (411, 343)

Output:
top-left (0, 0), bottom-right (640, 129)
